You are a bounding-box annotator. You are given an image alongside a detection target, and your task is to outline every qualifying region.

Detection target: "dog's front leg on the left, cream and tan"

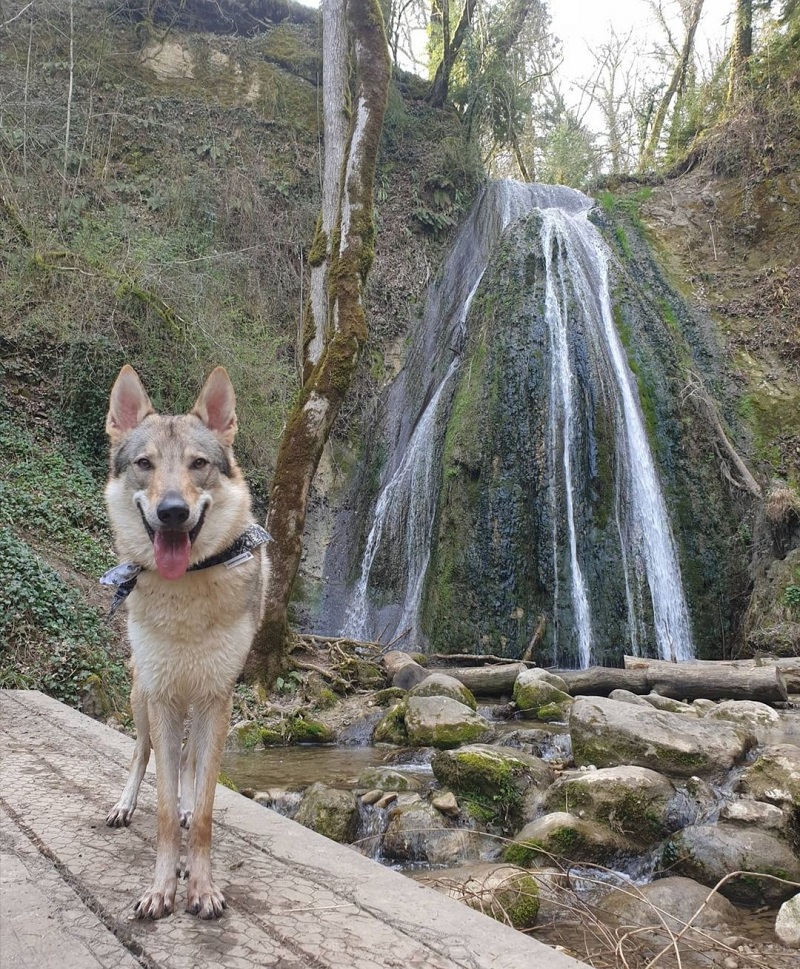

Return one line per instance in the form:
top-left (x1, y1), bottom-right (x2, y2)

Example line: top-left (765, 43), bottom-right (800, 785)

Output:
top-left (134, 700), bottom-right (184, 919)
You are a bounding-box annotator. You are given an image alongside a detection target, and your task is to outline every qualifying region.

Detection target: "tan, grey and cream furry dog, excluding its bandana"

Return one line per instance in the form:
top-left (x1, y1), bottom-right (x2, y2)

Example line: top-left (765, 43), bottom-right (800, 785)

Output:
top-left (106, 366), bottom-right (268, 919)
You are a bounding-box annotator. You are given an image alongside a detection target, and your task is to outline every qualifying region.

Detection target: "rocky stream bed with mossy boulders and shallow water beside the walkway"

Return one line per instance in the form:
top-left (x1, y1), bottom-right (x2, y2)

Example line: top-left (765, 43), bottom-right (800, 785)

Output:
top-left (224, 656), bottom-right (800, 969)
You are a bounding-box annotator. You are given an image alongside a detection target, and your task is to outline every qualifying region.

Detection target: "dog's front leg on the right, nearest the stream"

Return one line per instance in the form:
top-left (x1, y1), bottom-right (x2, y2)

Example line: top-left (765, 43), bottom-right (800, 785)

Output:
top-left (186, 696), bottom-right (232, 919)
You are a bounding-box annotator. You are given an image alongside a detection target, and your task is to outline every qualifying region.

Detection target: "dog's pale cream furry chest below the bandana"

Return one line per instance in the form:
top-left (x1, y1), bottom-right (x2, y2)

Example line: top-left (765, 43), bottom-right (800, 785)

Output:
top-left (128, 568), bottom-right (258, 703)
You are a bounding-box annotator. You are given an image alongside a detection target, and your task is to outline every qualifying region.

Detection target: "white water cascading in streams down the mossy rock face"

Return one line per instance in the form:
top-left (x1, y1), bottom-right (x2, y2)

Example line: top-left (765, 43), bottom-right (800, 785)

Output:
top-left (338, 182), bottom-right (693, 666)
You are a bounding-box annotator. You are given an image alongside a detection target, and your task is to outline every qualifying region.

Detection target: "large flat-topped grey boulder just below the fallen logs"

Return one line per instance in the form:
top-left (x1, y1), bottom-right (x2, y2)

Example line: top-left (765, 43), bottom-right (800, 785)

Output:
top-left (569, 697), bottom-right (755, 777)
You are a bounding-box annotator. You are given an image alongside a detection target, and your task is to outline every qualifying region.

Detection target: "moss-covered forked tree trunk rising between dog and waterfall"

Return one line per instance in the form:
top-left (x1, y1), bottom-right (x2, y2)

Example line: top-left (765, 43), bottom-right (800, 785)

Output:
top-left (247, 0), bottom-right (389, 684)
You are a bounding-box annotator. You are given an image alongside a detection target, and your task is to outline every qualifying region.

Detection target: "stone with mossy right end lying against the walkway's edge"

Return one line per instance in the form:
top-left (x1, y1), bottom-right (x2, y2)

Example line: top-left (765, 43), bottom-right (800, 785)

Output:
top-left (415, 863), bottom-right (539, 929)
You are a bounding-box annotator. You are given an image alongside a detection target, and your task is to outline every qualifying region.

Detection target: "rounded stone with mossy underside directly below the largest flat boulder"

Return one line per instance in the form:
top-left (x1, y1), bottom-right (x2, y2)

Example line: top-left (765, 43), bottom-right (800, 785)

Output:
top-left (543, 767), bottom-right (677, 845)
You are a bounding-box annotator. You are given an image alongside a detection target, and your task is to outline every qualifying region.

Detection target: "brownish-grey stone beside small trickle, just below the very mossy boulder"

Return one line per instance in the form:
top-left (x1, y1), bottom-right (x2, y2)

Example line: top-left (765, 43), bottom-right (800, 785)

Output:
top-left (382, 794), bottom-right (496, 867)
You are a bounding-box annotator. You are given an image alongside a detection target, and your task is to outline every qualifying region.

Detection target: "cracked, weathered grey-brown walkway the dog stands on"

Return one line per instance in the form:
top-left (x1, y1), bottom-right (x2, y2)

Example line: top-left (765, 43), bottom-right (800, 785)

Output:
top-left (0, 691), bottom-right (582, 969)
